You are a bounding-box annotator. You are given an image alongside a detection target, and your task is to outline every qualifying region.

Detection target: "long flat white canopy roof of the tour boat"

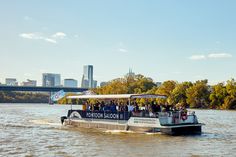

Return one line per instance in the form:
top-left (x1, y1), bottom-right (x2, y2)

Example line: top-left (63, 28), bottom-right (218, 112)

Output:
top-left (67, 94), bottom-right (166, 99)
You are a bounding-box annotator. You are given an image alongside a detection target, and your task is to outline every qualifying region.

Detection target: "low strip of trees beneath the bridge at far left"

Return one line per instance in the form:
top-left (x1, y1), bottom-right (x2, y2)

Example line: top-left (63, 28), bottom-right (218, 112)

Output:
top-left (0, 91), bottom-right (49, 103)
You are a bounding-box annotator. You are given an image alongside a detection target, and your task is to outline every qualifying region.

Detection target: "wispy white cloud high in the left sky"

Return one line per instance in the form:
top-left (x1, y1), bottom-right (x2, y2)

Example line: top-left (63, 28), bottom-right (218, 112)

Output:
top-left (19, 32), bottom-right (66, 44)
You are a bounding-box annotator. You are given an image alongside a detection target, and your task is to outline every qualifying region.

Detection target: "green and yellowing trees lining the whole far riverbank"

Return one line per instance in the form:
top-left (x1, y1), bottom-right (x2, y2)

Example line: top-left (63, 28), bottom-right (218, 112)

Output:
top-left (0, 74), bottom-right (236, 110)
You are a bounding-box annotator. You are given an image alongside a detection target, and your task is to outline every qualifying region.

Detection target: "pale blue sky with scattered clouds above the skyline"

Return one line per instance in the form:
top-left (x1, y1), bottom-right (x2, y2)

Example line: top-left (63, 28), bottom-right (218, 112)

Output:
top-left (0, 0), bottom-right (236, 85)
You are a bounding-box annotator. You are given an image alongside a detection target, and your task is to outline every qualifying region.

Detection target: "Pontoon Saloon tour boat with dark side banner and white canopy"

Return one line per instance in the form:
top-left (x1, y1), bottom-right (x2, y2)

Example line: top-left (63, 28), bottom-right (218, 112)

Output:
top-left (61, 94), bottom-right (203, 135)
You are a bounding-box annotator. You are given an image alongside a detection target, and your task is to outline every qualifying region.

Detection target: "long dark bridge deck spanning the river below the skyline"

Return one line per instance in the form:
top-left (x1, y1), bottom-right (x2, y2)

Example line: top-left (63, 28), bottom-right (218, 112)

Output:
top-left (0, 85), bottom-right (88, 92)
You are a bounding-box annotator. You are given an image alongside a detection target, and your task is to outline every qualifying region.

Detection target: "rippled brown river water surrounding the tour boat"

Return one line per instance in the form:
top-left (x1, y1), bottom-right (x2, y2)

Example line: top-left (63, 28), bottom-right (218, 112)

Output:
top-left (0, 104), bottom-right (236, 157)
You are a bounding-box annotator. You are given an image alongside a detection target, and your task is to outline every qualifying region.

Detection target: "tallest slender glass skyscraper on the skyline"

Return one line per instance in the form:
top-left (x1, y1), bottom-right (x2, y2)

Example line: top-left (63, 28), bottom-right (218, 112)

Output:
top-left (81, 65), bottom-right (97, 88)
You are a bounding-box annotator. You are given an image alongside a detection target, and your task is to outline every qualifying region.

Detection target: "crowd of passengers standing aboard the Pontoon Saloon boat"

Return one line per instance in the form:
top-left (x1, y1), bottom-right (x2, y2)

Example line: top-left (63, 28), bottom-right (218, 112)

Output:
top-left (85, 101), bottom-right (185, 113)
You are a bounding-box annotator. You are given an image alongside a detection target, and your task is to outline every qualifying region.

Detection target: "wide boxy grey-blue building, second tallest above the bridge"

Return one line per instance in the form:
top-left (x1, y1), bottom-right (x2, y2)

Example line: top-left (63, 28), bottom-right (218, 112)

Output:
top-left (42, 73), bottom-right (61, 87)
